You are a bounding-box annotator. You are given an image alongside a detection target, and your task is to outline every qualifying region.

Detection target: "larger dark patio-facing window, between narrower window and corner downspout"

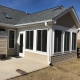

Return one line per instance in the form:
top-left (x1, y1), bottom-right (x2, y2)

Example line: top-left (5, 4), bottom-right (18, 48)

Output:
top-left (37, 30), bottom-right (47, 52)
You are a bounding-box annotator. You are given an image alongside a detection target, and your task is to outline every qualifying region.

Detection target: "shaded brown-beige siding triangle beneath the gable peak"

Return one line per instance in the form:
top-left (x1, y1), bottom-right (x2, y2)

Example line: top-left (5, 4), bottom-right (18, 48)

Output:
top-left (57, 12), bottom-right (77, 28)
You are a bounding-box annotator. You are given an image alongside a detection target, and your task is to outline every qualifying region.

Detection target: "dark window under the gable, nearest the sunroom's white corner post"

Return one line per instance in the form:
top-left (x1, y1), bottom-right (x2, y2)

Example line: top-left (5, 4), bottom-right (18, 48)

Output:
top-left (54, 30), bottom-right (62, 52)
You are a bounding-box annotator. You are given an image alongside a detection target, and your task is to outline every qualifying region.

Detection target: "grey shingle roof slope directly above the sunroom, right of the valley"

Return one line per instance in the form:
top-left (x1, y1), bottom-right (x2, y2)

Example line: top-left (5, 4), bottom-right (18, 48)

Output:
top-left (18, 8), bottom-right (68, 24)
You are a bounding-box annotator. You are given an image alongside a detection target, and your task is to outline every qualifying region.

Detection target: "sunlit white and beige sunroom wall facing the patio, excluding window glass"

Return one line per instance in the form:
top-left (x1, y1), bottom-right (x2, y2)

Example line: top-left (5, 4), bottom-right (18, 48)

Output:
top-left (17, 25), bottom-right (50, 63)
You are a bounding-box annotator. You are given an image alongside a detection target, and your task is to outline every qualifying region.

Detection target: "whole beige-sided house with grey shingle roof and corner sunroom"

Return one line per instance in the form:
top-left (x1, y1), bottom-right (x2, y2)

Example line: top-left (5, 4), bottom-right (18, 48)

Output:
top-left (0, 5), bottom-right (79, 64)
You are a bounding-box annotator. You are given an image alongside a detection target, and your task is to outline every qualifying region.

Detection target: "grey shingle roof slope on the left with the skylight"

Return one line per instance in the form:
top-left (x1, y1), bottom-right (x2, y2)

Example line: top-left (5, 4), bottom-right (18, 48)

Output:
top-left (0, 5), bottom-right (26, 25)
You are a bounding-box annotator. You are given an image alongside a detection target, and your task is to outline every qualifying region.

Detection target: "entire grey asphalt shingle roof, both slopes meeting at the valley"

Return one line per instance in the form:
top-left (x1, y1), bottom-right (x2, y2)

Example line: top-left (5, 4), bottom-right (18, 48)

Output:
top-left (0, 5), bottom-right (68, 25)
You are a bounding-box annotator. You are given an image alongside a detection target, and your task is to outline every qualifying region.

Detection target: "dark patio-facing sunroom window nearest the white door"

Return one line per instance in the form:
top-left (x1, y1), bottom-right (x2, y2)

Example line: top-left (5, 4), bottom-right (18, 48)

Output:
top-left (26, 31), bottom-right (33, 49)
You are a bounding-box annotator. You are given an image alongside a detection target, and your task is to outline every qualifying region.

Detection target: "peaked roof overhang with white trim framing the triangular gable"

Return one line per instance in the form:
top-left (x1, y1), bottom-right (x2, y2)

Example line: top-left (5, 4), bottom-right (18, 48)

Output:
top-left (53, 6), bottom-right (80, 28)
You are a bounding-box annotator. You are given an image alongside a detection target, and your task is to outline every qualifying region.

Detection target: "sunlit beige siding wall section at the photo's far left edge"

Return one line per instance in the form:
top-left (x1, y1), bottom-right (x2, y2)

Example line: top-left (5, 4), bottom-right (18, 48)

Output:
top-left (0, 37), bottom-right (7, 56)
